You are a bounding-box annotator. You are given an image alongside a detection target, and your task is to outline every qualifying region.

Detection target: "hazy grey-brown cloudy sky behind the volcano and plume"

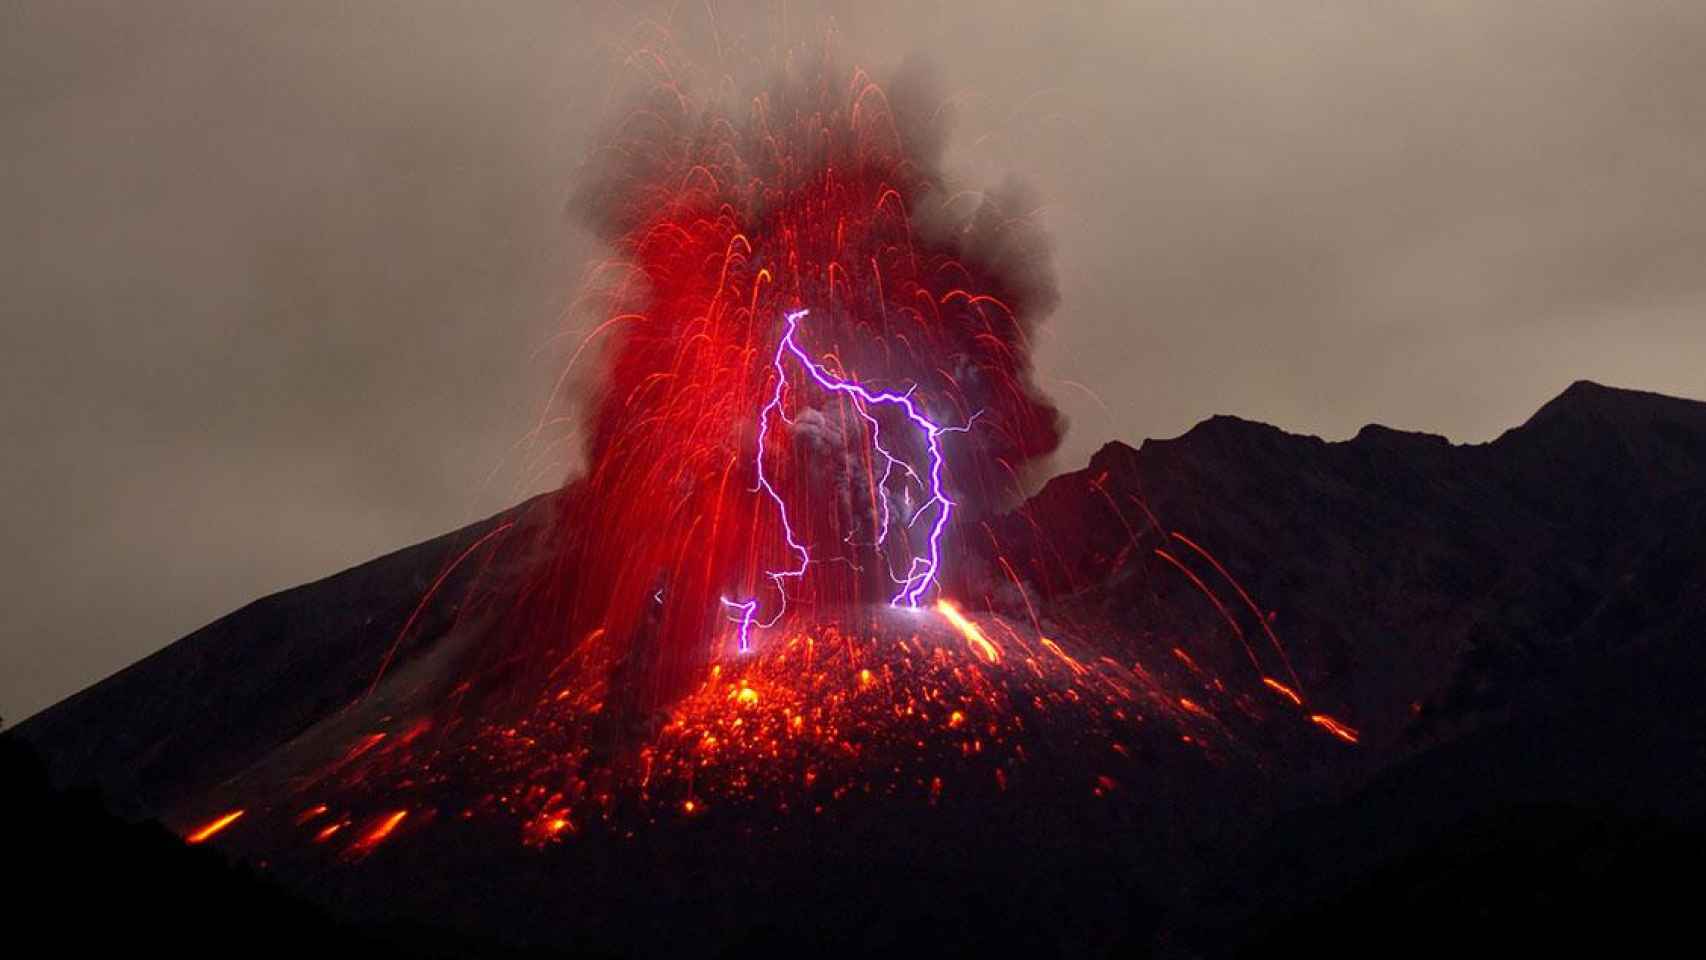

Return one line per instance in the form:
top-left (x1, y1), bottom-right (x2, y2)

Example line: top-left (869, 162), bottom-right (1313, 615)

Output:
top-left (0, 0), bottom-right (1706, 721)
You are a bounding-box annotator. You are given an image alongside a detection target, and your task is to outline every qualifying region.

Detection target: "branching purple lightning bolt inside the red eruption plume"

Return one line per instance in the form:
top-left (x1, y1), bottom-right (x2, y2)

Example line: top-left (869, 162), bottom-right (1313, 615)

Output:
top-left (722, 310), bottom-right (978, 651)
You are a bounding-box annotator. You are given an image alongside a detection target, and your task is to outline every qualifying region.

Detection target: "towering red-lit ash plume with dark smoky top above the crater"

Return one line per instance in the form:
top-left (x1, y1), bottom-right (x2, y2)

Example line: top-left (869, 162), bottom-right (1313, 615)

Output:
top-left (494, 49), bottom-right (1063, 705)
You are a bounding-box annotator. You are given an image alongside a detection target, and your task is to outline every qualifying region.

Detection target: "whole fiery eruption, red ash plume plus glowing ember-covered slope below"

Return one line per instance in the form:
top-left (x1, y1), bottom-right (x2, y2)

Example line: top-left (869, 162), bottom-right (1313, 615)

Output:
top-left (176, 55), bottom-right (1358, 861)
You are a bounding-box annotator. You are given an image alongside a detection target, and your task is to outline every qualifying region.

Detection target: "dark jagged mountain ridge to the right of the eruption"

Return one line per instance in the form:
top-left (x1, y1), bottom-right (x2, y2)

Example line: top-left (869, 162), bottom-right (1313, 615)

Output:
top-left (1005, 382), bottom-right (1706, 763)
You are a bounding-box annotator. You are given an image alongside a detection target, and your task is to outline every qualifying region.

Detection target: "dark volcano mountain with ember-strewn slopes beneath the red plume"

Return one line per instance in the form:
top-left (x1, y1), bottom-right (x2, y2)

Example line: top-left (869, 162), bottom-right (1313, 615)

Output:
top-left (9, 382), bottom-right (1706, 955)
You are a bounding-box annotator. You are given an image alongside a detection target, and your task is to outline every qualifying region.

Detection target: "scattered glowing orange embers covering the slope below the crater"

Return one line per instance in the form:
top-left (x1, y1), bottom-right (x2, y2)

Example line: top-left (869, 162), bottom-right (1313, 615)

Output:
top-left (188, 602), bottom-right (1356, 861)
